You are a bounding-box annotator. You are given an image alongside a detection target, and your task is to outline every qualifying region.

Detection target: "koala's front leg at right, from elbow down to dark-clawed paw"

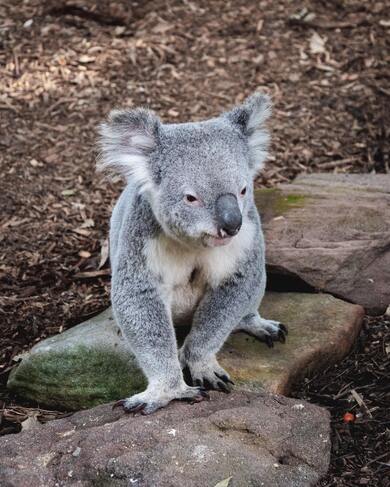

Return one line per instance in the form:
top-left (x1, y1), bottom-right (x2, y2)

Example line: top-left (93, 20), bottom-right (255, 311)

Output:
top-left (179, 273), bottom-right (257, 392)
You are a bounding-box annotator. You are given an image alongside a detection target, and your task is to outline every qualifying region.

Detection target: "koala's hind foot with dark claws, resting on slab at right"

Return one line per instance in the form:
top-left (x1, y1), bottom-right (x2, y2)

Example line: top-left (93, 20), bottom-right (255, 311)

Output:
top-left (235, 312), bottom-right (288, 348)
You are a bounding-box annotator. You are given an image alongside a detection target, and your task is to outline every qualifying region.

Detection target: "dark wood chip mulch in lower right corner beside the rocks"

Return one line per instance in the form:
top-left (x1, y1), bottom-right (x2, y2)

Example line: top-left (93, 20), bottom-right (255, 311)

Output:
top-left (292, 316), bottom-right (390, 487)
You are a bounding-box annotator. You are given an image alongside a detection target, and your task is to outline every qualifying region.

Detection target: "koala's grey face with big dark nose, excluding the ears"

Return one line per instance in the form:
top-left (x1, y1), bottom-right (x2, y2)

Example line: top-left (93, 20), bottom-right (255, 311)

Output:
top-left (151, 123), bottom-right (253, 246)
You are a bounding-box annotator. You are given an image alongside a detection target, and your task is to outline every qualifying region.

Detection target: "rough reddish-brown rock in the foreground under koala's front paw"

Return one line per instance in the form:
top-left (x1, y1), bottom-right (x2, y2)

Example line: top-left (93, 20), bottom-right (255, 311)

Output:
top-left (0, 392), bottom-right (330, 487)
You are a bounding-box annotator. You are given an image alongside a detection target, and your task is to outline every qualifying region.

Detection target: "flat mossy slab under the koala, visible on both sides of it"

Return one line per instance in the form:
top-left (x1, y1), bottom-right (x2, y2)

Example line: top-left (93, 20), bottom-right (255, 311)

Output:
top-left (8, 293), bottom-right (363, 410)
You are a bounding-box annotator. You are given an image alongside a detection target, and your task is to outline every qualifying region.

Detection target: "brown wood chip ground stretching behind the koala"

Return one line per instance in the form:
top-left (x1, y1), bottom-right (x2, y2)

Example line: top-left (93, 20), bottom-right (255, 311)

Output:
top-left (0, 0), bottom-right (390, 485)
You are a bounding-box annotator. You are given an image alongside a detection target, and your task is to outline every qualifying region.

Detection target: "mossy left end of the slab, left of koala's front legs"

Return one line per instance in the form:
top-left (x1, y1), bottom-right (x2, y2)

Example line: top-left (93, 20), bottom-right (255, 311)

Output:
top-left (7, 310), bottom-right (146, 411)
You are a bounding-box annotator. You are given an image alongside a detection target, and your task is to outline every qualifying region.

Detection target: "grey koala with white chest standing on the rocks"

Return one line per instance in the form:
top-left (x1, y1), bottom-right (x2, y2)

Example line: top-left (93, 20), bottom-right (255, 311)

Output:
top-left (98, 93), bottom-right (287, 414)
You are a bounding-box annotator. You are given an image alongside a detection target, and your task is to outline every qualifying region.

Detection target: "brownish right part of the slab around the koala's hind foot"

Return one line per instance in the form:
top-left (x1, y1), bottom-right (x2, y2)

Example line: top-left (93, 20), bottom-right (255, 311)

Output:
top-left (220, 293), bottom-right (364, 395)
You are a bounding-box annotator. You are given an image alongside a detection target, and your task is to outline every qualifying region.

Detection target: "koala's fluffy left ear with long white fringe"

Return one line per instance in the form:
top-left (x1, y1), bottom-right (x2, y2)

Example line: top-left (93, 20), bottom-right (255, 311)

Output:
top-left (97, 108), bottom-right (161, 191)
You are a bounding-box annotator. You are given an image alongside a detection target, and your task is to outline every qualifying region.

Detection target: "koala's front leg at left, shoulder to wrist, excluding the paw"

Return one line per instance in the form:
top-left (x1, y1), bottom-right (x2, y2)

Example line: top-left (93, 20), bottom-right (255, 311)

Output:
top-left (110, 195), bottom-right (182, 387)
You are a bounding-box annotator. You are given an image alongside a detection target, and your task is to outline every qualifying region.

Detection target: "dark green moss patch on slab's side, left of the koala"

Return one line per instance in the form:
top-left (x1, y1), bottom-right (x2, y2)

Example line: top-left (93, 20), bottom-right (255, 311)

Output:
top-left (8, 345), bottom-right (146, 410)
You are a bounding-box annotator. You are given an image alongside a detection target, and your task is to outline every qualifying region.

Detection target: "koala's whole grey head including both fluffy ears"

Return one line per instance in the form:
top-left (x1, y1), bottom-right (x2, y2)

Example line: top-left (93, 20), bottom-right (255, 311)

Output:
top-left (99, 94), bottom-right (271, 250)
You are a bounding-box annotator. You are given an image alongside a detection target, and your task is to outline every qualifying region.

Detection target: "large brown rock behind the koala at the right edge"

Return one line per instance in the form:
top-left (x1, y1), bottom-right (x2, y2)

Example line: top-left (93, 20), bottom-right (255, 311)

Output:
top-left (257, 174), bottom-right (390, 314)
